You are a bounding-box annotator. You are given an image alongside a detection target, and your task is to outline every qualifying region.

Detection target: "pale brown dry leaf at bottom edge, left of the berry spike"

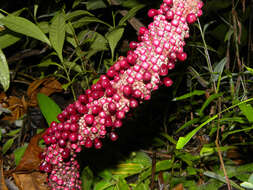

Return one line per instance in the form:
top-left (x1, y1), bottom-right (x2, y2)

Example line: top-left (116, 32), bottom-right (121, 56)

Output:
top-left (12, 172), bottom-right (49, 190)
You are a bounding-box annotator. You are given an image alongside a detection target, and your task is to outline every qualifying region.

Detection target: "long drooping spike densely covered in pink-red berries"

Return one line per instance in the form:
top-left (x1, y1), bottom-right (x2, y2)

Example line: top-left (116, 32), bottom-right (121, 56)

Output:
top-left (40, 0), bottom-right (203, 190)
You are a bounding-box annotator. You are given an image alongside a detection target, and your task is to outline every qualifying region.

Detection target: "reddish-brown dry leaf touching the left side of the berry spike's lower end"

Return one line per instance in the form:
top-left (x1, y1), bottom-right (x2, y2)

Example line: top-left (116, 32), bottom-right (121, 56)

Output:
top-left (15, 133), bottom-right (43, 172)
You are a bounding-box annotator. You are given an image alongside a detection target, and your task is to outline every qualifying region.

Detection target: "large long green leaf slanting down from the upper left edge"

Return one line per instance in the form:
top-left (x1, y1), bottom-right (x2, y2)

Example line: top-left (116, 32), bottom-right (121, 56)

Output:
top-left (0, 15), bottom-right (51, 46)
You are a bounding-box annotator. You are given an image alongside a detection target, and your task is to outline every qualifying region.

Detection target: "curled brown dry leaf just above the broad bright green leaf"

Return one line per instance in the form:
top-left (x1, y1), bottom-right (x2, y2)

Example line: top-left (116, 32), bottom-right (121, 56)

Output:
top-left (27, 77), bottom-right (63, 106)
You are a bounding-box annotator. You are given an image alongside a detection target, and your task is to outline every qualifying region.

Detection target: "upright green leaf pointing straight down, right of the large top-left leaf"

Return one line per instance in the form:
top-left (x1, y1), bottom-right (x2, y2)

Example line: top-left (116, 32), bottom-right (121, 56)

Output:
top-left (49, 13), bottom-right (65, 62)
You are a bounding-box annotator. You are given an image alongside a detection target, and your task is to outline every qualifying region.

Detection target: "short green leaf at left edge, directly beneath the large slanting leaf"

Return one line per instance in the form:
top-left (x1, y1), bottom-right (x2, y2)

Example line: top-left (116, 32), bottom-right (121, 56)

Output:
top-left (0, 29), bottom-right (21, 49)
